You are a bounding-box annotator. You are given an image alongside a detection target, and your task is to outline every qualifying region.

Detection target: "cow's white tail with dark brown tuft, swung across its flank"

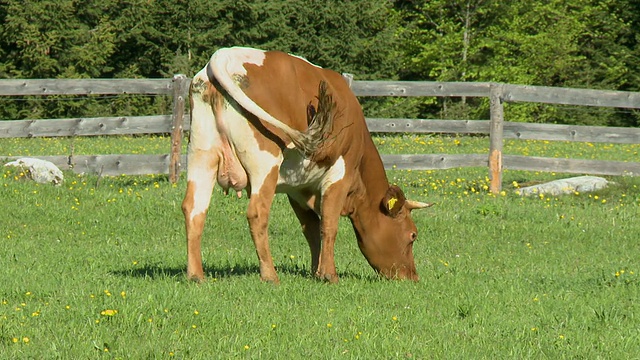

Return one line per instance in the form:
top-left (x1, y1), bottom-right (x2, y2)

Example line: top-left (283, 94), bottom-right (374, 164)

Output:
top-left (209, 54), bottom-right (335, 157)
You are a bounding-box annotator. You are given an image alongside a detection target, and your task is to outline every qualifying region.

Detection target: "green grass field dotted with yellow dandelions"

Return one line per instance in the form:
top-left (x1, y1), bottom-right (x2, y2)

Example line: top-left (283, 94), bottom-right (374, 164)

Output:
top-left (0, 136), bottom-right (640, 359)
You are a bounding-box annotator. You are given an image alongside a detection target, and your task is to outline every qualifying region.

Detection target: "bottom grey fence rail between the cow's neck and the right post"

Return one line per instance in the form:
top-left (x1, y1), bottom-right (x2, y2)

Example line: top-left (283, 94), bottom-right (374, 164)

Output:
top-left (381, 154), bottom-right (488, 170)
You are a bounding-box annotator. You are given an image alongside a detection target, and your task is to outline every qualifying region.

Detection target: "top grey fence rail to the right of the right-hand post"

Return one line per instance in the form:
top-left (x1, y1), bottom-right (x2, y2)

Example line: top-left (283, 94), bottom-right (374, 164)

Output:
top-left (502, 84), bottom-right (640, 109)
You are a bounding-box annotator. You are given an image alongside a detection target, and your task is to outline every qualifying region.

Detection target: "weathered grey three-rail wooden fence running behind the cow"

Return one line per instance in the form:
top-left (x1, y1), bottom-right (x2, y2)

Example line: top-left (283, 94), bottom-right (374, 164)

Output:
top-left (0, 75), bottom-right (640, 192)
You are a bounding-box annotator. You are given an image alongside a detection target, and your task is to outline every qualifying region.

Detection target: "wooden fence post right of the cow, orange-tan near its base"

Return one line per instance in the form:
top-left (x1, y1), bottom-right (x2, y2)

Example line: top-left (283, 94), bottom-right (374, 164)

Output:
top-left (489, 84), bottom-right (504, 194)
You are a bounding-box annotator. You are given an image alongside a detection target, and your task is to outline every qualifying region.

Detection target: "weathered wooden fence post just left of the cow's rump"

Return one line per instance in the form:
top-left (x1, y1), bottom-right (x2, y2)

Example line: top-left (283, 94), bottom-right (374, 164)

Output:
top-left (169, 74), bottom-right (189, 184)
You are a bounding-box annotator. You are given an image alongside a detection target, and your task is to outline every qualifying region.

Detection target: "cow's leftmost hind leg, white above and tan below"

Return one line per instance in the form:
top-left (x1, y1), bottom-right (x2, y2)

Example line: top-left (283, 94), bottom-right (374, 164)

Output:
top-left (182, 150), bottom-right (219, 281)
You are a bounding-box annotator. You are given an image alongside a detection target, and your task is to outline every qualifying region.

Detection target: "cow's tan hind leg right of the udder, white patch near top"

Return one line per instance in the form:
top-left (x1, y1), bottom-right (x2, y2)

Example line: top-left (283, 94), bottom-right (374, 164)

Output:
top-left (247, 167), bottom-right (280, 284)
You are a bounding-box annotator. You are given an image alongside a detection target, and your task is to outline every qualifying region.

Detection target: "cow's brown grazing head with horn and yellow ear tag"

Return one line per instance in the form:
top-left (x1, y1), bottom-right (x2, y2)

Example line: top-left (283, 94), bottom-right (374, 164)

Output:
top-left (354, 185), bottom-right (432, 281)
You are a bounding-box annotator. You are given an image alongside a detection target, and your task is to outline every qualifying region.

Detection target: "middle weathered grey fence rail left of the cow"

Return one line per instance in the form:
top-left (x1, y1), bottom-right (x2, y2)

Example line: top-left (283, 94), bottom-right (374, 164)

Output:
top-left (0, 115), bottom-right (171, 138)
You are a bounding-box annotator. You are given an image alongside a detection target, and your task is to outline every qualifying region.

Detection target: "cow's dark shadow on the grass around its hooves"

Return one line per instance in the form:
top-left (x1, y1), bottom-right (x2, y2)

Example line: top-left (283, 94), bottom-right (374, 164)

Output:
top-left (110, 264), bottom-right (379, 281)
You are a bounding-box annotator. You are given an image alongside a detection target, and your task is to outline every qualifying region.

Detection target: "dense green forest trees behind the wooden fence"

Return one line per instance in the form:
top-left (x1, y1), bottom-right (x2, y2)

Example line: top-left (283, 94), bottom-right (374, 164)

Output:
top-left (0, 0), bottom-right (640, 126)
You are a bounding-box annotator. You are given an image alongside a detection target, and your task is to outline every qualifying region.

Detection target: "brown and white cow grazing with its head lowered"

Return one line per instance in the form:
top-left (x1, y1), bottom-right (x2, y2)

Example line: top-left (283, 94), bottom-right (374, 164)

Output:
top-left (182, 47), bottom-right (429, 282)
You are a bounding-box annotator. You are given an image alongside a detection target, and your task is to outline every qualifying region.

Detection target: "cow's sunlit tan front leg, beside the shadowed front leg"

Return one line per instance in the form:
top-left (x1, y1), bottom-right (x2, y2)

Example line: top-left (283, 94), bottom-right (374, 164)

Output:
top-left (316, 184), bottom-right (346, 283)
